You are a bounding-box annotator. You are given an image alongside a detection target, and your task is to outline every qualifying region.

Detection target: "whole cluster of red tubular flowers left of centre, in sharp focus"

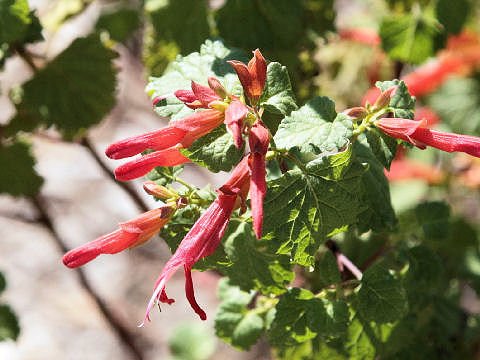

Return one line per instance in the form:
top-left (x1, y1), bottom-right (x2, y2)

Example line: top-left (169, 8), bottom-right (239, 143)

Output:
top-left (63, 49), bottom-right (270, 325)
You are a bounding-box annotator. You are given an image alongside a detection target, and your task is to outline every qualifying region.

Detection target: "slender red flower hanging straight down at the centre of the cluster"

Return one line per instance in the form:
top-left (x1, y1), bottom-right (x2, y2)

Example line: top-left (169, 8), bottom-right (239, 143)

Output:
top-left (248, 121), bottom-right (270, 239)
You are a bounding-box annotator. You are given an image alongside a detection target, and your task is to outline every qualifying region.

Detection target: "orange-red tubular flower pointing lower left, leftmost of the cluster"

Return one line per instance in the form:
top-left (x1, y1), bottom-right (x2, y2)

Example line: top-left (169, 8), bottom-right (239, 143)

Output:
top-left (63, 205), bottom-right (174, 268)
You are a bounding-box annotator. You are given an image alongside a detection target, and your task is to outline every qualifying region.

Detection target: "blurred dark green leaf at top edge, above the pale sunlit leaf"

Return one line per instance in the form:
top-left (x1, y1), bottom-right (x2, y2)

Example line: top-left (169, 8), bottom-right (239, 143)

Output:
top-left (145, 0), bottom-right (210, 54)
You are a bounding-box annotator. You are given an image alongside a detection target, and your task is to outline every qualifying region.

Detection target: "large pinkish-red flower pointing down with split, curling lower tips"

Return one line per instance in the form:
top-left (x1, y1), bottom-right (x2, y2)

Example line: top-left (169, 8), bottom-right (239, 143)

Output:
top-left (140, 191), bottom-right (237, 326)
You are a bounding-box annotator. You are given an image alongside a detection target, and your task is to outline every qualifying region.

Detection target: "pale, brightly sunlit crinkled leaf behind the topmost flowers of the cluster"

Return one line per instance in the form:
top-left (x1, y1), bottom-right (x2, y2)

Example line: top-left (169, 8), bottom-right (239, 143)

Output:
top-left (145, 40), bottom-right (248, 120)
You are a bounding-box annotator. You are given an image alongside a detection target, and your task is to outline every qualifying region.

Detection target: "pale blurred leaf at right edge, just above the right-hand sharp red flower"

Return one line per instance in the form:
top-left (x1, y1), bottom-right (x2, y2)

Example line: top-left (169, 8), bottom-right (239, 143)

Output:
top-left (427, 78), bottom-right (480, 135)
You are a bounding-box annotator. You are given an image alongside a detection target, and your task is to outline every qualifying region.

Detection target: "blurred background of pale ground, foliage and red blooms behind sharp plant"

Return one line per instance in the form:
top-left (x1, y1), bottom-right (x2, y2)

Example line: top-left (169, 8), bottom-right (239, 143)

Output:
top-left (0, 0), bottom-right (480, 360)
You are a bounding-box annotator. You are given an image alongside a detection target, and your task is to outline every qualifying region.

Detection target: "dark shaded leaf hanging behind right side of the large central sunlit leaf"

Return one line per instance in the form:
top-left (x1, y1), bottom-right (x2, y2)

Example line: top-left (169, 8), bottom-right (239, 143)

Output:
top-left (354, 136), bottom-right (397, 232)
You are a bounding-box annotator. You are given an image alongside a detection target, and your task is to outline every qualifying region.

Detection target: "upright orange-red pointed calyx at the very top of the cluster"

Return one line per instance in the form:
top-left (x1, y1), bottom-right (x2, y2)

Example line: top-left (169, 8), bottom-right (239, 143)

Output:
top-left (227, 49), bottom-right (267, 105)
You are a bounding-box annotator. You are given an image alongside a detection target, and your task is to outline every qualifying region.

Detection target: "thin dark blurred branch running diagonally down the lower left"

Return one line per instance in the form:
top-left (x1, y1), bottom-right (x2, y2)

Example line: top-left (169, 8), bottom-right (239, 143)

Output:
top-left (31, 195), bottom-right (144, 360)
